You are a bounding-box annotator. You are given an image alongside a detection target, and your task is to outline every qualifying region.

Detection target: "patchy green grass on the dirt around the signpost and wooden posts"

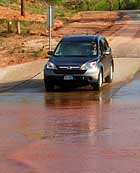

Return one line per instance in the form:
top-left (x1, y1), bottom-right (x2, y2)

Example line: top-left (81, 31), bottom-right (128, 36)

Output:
top-left (0, 0), bottom-right (75, 35)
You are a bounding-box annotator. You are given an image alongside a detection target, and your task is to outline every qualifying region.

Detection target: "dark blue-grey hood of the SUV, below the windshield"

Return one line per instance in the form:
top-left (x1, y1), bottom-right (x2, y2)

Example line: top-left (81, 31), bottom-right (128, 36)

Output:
top-left (49, 57), bottom-right (98, 66)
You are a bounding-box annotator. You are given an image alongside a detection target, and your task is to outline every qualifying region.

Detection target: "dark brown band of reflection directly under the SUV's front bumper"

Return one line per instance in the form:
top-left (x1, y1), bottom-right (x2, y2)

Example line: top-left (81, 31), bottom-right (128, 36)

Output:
top-left (44, 86), bottom-right (113, 106)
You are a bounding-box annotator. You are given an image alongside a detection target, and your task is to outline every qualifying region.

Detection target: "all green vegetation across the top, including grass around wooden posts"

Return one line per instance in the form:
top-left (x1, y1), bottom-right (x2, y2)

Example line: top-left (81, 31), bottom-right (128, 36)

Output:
top-left (0, 0), bottom-right (140, 34)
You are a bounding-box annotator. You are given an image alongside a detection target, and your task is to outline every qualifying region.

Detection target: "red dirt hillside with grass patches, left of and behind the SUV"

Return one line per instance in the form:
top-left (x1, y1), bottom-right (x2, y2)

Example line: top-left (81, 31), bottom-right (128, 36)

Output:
top-left (0, 2), bottom-right (119, 67)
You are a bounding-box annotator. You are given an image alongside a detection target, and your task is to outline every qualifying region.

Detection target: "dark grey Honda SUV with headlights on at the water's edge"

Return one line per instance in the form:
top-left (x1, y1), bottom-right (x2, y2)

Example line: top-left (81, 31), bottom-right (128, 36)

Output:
top-left (44, 35), bottom-right (114, 91)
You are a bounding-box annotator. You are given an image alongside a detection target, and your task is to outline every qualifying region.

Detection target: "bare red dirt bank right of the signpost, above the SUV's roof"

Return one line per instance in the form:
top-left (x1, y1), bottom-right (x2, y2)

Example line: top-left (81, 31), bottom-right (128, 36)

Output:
top-left (54, 11), bottom-right (119, 38)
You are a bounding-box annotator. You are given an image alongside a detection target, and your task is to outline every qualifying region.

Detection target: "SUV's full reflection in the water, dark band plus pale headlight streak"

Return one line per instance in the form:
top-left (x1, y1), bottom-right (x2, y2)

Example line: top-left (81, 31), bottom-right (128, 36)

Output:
top-left (42, 91), bottom-right (111, 142)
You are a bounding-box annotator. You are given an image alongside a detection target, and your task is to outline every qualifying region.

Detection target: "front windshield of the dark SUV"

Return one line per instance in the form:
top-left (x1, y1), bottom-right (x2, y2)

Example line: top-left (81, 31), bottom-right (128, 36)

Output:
top-left (54, 41), bottom-right (97, 57)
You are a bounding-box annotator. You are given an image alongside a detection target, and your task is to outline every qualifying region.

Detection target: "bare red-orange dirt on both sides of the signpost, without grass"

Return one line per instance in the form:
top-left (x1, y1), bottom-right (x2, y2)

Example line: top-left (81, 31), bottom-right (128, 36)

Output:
top-left (0, 7), bottom-right (122, 67)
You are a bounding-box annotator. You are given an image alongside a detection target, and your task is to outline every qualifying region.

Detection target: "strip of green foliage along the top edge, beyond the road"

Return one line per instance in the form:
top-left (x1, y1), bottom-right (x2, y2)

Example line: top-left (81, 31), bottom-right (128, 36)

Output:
top-left (0, 0), bottom-right (140, 14)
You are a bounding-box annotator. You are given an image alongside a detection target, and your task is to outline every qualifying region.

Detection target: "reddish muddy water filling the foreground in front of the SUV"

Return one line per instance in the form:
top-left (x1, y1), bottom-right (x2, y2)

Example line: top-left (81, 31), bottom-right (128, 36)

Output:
top-left (0, 97), bottom-right (140, 173)
